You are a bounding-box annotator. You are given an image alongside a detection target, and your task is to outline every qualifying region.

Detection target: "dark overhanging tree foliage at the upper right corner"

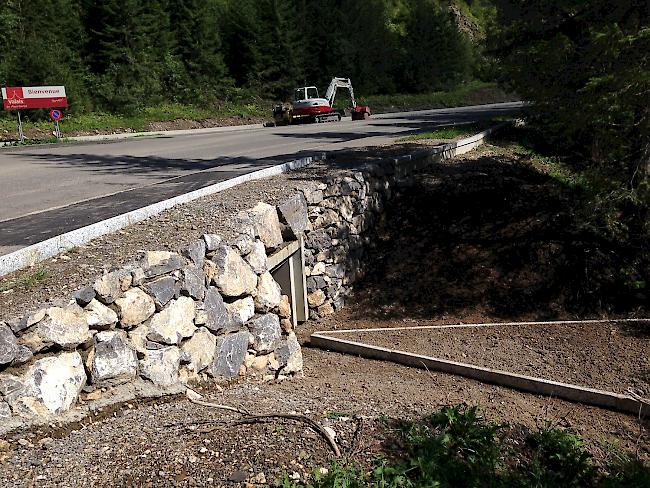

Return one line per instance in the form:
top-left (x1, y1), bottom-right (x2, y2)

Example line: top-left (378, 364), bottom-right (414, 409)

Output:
top-left (490, 0), bottom-right (650, 249)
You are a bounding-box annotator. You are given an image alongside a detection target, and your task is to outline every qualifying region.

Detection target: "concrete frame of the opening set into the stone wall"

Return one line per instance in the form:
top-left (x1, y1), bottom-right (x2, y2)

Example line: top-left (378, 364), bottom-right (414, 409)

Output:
top-left (268, 237), bottom-right (309, 327)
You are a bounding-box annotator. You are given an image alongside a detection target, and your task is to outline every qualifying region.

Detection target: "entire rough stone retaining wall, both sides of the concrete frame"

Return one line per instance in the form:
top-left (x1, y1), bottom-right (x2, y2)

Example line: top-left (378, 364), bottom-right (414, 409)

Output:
top-left (0, 150), bottom-right (436, 425)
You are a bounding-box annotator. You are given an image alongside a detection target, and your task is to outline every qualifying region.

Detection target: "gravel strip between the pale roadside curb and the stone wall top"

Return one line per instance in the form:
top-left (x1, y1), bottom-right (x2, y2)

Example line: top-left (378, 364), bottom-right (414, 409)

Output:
top-left (0, 140), bottom-right (449, 322)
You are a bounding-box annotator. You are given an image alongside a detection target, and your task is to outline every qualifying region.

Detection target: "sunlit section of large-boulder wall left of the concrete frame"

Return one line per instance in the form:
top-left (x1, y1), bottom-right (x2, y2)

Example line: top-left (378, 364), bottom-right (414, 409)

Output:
top-left (0, 198), bottom-right (308, 428)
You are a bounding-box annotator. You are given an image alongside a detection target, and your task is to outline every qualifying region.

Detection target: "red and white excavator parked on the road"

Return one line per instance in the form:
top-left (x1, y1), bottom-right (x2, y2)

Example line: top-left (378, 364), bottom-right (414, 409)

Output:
top-left (273, 78), bottom-right (370, 125)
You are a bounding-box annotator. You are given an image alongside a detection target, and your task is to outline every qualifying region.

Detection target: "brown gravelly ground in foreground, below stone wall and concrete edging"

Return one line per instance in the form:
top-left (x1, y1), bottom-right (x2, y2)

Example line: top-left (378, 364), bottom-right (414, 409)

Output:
top-left (0, 348), bottom-right (650, 487)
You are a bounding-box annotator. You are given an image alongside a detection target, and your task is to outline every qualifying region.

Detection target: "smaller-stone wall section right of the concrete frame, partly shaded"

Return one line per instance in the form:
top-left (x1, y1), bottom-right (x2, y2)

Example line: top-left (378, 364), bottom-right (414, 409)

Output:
top-left (303, 153), bottom-right (418, 318)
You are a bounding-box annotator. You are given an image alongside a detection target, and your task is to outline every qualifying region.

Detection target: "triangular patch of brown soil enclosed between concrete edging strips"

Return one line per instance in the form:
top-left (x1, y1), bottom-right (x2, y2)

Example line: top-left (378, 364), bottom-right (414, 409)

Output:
top-left (342, 322), bottom-right (650, 398)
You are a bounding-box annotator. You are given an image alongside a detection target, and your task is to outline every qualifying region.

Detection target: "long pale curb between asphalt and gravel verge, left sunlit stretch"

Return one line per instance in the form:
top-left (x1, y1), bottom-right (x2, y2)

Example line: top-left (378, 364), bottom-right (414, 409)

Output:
top-left (0, 153), bottom-right (325, 277)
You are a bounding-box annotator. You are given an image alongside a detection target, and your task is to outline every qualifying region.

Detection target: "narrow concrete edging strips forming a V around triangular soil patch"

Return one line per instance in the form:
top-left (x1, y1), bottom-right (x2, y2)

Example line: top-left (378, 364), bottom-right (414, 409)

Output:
top-left (310, 319), bottom-right (650, 415)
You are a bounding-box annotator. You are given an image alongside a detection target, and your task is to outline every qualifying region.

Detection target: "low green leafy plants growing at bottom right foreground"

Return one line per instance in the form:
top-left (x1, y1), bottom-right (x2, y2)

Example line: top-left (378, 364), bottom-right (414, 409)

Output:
top-left (284, 405), bottom-right (650, 488)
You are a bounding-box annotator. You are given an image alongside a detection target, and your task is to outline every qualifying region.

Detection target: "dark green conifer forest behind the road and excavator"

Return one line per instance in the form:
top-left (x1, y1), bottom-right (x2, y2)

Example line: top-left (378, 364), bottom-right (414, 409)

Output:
top-left (0, 0), bottom-right (485, 112)
